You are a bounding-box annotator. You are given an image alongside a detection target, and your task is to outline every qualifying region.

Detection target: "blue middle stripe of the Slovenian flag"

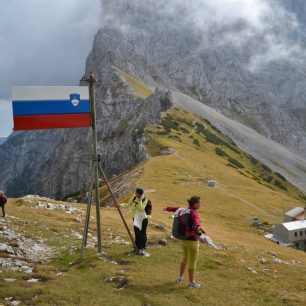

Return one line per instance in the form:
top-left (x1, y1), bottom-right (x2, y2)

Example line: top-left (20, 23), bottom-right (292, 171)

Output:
top-left (13, 100), bottom-right (90, 116)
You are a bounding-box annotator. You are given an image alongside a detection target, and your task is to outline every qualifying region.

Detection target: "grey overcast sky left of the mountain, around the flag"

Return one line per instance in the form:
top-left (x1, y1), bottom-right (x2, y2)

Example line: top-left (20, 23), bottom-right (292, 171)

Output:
top-left (0, 0), bottom-right (101, 137)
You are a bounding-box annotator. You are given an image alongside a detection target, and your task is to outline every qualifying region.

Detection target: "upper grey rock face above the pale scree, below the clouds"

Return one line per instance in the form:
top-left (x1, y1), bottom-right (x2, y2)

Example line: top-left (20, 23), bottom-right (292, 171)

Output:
top-left (95, 0), bottom-right (306, 157)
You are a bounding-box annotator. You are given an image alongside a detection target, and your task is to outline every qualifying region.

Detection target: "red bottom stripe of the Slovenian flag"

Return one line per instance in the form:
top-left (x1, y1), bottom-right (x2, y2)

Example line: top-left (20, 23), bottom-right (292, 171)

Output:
top-left (14, 114), bottom-right (91, 131)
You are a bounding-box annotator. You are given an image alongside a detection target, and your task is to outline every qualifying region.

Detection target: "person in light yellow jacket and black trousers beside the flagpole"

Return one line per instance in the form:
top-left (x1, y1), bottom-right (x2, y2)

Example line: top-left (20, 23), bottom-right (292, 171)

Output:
top-left (121, 188), bottom-right (152, 257)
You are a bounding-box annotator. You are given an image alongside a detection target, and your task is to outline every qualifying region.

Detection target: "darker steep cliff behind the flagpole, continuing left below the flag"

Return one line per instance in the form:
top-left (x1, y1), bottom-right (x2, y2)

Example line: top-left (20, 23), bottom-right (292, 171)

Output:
top-left (0, 65), bottom-right (171, 198)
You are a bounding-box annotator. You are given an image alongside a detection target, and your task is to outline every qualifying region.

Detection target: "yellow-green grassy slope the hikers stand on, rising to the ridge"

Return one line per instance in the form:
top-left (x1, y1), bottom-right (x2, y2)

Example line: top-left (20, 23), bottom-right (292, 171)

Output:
top-left (0, 110), bottom-right (306, 305)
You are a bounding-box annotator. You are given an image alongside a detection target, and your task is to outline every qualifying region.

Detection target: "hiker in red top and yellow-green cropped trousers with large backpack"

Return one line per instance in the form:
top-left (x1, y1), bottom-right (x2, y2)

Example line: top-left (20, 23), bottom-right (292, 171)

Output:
top-left (164, 196), bottom-right (205, 288)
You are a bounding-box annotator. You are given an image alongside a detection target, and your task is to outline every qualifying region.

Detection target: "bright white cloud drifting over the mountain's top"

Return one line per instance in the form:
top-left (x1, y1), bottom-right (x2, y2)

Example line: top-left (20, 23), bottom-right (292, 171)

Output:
top-left (101, 0), bottom-right (305, 72)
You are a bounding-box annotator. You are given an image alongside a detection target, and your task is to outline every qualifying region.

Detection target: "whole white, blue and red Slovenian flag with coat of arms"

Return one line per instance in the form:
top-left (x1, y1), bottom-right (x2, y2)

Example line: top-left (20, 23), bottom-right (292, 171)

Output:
top-left (12, 86), bottom-right (91, 131)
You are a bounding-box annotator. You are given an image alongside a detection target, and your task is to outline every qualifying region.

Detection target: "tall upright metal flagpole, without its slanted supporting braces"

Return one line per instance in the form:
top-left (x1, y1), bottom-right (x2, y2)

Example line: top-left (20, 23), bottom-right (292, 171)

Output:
top-left (87, 72), bottom-right (102, 253)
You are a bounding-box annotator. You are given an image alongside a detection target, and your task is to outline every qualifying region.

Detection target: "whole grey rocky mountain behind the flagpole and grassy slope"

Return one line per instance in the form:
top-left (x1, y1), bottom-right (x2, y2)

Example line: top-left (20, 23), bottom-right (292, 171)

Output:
top-left (0, 0), bottom-right (306, 198)
